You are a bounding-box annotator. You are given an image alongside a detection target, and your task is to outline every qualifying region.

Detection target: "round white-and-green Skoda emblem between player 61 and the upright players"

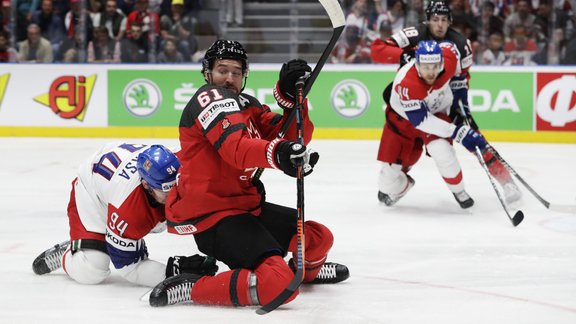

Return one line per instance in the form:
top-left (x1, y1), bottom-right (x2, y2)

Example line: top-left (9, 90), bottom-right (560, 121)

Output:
top-left (330, 80), bottom-right (370, 118)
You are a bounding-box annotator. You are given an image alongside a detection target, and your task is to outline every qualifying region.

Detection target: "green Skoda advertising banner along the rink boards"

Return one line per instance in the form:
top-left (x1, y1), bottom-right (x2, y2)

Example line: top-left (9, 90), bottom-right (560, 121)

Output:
top-left (108, 70), bottom-right (534, 130)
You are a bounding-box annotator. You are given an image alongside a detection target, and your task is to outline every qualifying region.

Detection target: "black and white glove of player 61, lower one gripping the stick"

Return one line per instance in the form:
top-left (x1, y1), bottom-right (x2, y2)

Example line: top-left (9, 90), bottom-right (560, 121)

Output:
top-left (268, 140), bottom-right (320, 178)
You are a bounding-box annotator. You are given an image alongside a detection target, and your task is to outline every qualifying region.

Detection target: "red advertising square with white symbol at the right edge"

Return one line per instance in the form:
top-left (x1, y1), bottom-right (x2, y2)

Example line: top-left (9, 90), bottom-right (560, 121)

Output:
top-left (536, 73), bottom-right (576, 131)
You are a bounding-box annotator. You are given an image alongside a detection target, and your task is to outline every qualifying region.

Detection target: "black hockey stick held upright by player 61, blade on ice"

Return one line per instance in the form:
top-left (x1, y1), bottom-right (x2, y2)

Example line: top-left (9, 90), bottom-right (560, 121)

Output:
top-left (256, 77), bottom-right (306, 315)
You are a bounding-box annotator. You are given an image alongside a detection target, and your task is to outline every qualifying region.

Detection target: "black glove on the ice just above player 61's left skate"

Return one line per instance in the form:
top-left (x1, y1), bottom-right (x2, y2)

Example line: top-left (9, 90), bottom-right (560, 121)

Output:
top-left (166, 254), bottom-right (218, 278)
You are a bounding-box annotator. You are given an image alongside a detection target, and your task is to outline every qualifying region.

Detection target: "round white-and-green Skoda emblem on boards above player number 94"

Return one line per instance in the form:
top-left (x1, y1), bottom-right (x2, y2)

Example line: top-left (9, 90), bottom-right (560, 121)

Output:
top-left (122, 79), bottom-right (162, 117)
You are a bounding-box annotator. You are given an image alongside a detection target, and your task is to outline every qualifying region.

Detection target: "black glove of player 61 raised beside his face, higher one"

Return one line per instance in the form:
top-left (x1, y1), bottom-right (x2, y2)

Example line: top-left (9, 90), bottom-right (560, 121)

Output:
top-left (274, 59), bottom-right (312, 109)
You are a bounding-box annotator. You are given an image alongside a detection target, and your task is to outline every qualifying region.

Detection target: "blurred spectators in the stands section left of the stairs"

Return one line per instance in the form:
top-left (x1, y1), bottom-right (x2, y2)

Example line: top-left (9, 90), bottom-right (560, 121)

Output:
top-left (0, 0), bottom-right (207, 63)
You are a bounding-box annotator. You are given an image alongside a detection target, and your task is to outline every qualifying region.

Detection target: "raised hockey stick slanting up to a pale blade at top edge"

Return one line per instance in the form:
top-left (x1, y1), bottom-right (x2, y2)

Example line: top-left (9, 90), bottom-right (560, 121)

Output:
top-left (252, 0), bottom-right (346, 182)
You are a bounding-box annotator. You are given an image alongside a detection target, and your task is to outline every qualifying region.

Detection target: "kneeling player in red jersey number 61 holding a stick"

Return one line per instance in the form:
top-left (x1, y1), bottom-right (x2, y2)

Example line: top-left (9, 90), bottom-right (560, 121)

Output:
top-left (150, 40), bottom-right (348, 306)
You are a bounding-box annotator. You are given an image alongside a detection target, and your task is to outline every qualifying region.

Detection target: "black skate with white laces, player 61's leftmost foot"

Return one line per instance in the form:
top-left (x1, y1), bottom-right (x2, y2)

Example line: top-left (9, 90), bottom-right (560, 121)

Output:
top-left (150, 273), bottom-right (202, 307)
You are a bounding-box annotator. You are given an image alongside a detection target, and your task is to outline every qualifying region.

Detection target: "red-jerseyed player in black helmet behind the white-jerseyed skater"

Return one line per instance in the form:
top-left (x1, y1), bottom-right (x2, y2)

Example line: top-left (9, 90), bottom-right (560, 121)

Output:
top-left (370, 0), bottom-right (522, 206)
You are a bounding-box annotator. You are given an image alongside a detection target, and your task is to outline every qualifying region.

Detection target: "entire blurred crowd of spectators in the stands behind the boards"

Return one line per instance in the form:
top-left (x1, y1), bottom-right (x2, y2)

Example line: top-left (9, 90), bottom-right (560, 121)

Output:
top-left (0, 0), bottom-right (576, 65)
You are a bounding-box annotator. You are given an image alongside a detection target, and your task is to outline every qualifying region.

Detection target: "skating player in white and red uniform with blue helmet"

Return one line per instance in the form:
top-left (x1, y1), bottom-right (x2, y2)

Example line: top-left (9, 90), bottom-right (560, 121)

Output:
top-left (378, 40), bottom-right (486, 208)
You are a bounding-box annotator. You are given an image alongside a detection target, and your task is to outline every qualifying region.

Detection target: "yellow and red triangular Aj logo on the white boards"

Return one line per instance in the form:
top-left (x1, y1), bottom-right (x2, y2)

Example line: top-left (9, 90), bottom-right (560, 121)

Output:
top-left (34, 75), bottom-right (96, 121)
